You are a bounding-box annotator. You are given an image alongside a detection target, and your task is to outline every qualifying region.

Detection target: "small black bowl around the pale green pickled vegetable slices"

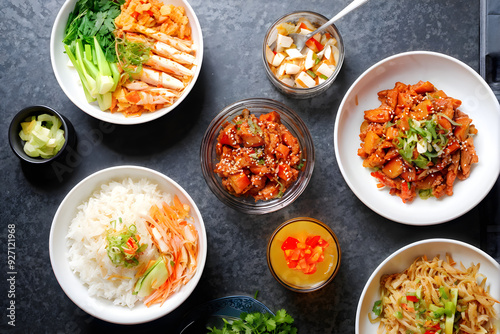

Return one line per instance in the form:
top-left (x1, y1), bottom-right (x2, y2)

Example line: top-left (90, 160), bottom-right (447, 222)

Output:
top-left (9, 105), bottom-right (76, 180)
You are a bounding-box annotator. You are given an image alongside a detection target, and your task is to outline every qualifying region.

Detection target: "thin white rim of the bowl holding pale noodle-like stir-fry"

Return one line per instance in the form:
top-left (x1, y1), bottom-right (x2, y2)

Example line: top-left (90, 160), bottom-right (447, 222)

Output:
top-left (356, 238), bottom-right (500, 334)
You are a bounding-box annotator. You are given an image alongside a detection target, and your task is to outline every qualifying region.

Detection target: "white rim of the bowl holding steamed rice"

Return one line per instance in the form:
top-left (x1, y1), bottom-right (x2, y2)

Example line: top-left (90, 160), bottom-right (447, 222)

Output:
top-left (49, 165), bottom-right (207, 325)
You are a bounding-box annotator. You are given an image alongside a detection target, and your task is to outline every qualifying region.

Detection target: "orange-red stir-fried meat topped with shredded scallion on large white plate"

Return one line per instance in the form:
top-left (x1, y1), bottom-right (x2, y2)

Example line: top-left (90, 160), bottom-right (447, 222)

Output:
top-left (358, 81), bottom-right (478, 203)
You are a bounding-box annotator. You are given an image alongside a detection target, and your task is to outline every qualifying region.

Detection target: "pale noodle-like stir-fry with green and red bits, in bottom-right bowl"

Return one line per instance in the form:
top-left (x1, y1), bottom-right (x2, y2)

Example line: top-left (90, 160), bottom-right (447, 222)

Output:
top-left (369, 254), bottom-right (499, 334)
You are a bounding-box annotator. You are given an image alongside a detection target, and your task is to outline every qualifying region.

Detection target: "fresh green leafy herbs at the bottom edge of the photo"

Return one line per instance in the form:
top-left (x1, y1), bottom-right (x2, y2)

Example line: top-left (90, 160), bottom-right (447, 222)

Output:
top-left (207, 309), bottom-right (297, 334)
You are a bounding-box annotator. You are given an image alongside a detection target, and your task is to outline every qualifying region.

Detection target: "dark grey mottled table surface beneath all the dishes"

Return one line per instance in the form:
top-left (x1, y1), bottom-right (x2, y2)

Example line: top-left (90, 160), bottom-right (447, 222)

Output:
top-left (0, 0), bottom-right (500, 334)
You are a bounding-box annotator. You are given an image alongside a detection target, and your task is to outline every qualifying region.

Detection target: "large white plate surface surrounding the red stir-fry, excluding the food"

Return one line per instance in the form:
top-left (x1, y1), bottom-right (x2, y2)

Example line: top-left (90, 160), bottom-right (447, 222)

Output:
top-left (334, 51), bottom-right (500, 225)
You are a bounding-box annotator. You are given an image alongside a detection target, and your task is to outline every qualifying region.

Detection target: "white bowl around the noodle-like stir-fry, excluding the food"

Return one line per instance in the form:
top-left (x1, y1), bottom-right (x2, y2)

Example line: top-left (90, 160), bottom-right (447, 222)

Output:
top-left (356, 239), bottom-right (500, 334)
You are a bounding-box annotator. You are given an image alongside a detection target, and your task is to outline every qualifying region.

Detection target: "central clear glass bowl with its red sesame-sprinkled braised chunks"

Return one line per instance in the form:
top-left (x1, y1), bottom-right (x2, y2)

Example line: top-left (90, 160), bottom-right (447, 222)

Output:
top-left (200, 98), bottom-right (314, 214)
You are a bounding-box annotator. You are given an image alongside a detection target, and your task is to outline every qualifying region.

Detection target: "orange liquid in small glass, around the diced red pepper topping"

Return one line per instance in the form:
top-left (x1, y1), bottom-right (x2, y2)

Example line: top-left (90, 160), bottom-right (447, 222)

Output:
top-left (267, 217), bottom-right (341, 292)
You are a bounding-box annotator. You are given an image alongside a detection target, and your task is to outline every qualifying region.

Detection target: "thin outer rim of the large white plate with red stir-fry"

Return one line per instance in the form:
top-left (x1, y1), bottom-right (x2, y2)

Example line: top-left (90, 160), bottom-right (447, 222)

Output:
top-left (333, 50), bottom-right (500, 226)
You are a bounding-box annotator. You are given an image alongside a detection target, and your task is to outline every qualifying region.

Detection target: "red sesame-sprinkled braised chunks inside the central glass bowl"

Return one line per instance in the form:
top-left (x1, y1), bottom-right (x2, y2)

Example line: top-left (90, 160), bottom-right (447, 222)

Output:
top-left (215, 109), bottom-right (302, 201)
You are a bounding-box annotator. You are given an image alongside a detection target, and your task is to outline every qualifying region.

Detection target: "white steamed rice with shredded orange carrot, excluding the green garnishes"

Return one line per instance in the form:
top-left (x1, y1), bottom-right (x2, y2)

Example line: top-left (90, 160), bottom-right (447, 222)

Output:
top-left (66, 178), bottom-right (198, 308)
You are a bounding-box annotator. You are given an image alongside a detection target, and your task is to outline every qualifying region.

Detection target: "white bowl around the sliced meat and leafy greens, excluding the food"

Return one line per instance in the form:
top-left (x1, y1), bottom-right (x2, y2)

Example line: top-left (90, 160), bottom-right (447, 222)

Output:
top-left (50, 0), bottom-right (203, 125)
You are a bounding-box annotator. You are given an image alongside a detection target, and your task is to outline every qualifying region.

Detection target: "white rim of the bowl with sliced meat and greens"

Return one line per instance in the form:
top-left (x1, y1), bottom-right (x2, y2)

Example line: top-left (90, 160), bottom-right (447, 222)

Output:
top-left (50, 0), bottom-right (204, 125)
